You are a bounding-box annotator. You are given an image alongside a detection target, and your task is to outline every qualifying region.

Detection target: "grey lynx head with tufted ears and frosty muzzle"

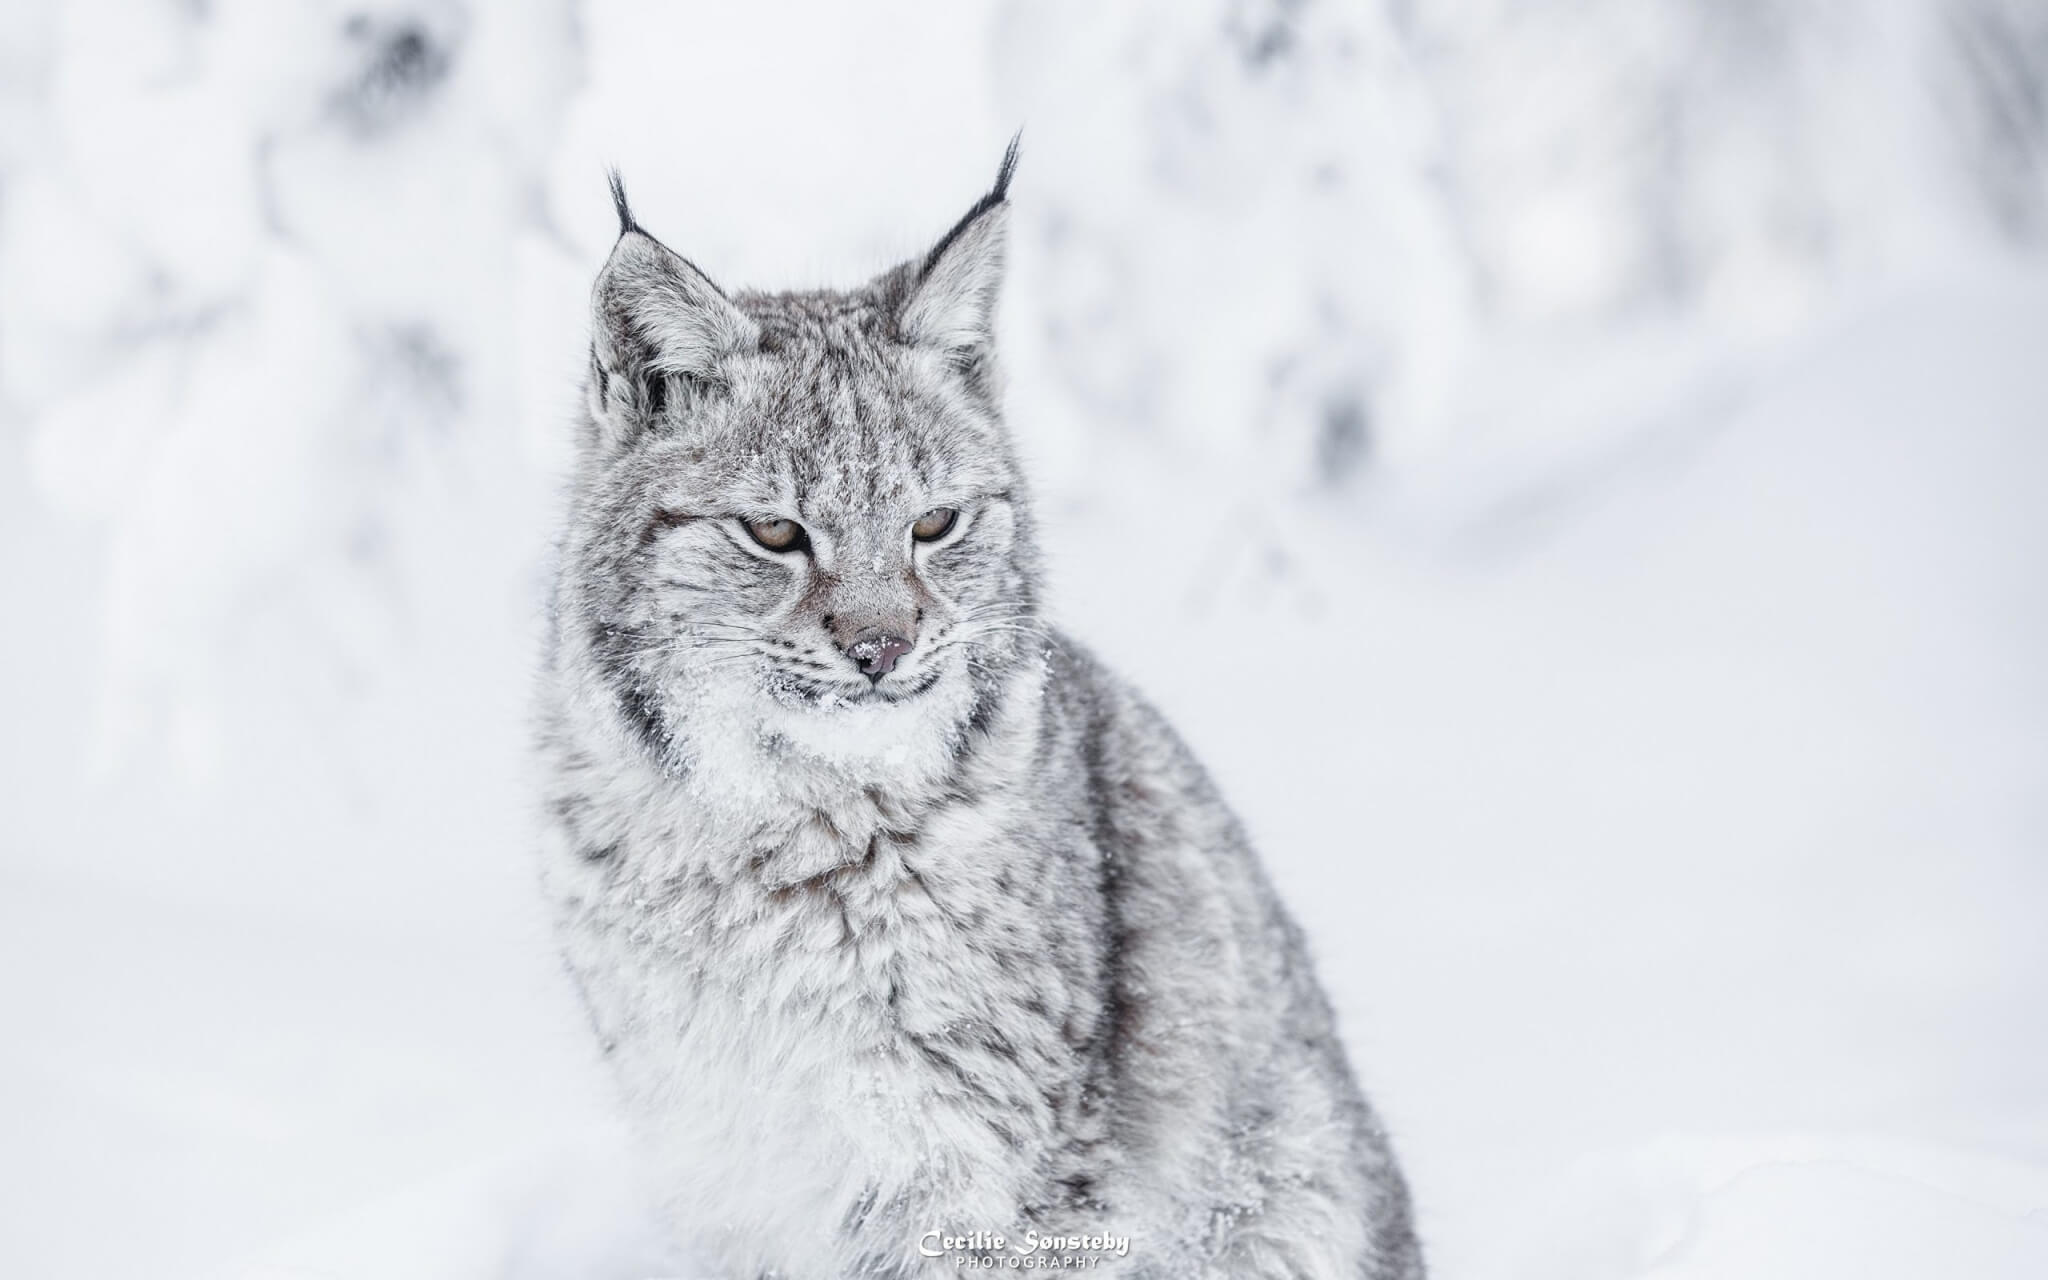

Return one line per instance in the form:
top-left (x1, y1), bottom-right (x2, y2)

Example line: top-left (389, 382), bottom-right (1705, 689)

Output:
top-left (559, 141), bottom-right (1036, 770)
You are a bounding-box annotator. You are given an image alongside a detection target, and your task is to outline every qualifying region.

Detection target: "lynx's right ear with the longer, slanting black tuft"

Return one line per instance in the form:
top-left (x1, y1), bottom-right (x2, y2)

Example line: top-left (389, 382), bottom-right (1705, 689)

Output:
top-left (897, 137), bottom-right (1018, 369)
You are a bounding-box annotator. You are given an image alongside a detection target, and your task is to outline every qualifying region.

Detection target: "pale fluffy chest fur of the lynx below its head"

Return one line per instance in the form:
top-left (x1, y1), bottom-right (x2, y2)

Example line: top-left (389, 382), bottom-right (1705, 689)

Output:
top-left (544, 782), bottom-right (1087, 1253)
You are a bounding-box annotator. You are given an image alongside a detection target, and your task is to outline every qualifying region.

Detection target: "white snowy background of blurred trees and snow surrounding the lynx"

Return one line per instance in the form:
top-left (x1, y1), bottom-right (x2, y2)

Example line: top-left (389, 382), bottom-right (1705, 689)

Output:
top-left (0, 0), bottom-right (2048, 1280)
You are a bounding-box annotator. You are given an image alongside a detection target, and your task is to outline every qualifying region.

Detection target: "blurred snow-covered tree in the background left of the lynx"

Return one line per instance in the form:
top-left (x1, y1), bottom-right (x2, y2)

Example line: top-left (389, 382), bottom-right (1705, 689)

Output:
top-left (0, 0), bottom-right (578, 772)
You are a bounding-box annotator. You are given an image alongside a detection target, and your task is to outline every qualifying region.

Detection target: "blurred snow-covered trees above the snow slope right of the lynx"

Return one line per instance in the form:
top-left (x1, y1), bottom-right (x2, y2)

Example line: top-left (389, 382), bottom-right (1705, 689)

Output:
top-left (997, 0), bottom-right (2048, 509)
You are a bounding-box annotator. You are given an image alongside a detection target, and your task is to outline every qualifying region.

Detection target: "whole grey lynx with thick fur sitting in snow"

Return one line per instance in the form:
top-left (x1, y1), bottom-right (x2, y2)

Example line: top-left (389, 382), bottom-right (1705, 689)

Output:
top-left (539, 143), bottom-right (1421, 1280)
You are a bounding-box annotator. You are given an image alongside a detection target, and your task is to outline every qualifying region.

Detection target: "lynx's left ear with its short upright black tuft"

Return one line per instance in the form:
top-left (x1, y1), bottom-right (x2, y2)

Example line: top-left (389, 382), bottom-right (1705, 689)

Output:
top-left (590, 172), bottom-right (760, 444)
